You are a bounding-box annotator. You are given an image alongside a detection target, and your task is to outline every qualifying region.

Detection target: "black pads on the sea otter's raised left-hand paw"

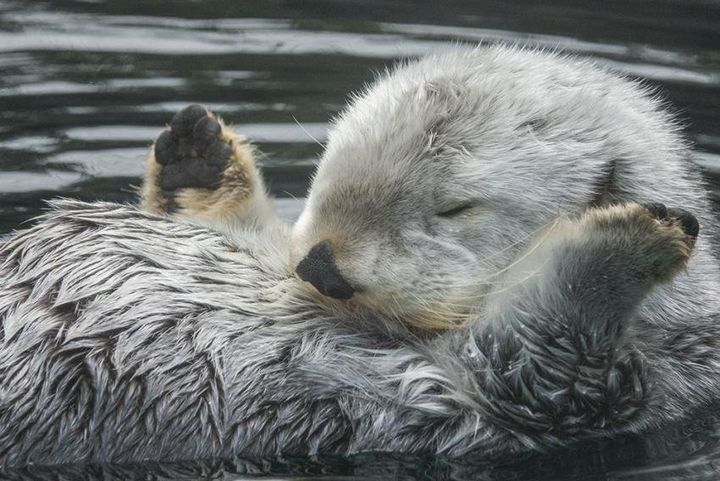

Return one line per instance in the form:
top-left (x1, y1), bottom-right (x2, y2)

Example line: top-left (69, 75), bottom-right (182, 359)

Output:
top-left (155, 105), bottom-right (233, 191)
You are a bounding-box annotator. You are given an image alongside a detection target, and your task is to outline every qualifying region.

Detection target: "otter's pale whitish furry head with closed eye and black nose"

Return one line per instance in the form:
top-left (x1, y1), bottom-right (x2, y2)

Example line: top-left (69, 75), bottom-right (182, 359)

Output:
top-left (291, 49), bottom-right (688, 328)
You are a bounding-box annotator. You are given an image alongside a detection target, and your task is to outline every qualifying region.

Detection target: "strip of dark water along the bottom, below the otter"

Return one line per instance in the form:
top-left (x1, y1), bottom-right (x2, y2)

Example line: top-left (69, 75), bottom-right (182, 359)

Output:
top-left (0, 408), bottom-right (720, 481)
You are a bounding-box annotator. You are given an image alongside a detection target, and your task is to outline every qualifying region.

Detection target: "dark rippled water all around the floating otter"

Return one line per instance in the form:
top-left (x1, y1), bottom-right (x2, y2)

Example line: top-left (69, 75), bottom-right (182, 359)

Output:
top-left (0, 0), bottom-right (720, 480)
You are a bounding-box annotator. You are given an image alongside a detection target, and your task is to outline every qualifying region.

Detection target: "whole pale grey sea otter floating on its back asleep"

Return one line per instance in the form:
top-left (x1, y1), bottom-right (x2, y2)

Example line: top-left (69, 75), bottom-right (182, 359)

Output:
top-left (0, 46), bottom-right (720, 466)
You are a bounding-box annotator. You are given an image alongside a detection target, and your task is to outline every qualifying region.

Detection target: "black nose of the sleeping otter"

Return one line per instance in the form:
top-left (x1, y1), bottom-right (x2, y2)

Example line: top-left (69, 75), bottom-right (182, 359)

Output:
top-left (295, 241), bottom-right (355, 299)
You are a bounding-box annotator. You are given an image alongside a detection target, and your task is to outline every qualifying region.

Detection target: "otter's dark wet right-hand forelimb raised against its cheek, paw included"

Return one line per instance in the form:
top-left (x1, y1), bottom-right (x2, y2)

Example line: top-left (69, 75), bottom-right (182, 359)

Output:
top-left (452, 204), bottom-right (698, 447)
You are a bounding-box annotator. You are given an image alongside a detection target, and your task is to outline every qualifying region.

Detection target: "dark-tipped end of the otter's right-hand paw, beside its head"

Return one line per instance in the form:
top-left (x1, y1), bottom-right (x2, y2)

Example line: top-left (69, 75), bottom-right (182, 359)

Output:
top-left (581, 203), bottom-right (700, 281)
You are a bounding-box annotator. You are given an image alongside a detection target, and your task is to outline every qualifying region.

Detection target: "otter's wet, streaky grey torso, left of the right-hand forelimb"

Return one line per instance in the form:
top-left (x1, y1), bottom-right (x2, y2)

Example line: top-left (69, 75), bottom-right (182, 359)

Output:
top-left (0, 202), bottom-right (516, 466)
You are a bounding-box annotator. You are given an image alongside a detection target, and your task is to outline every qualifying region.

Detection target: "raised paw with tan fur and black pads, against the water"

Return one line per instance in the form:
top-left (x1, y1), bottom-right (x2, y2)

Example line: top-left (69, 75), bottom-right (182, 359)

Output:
top-left (143, 105), bottom-right (268, 220)
